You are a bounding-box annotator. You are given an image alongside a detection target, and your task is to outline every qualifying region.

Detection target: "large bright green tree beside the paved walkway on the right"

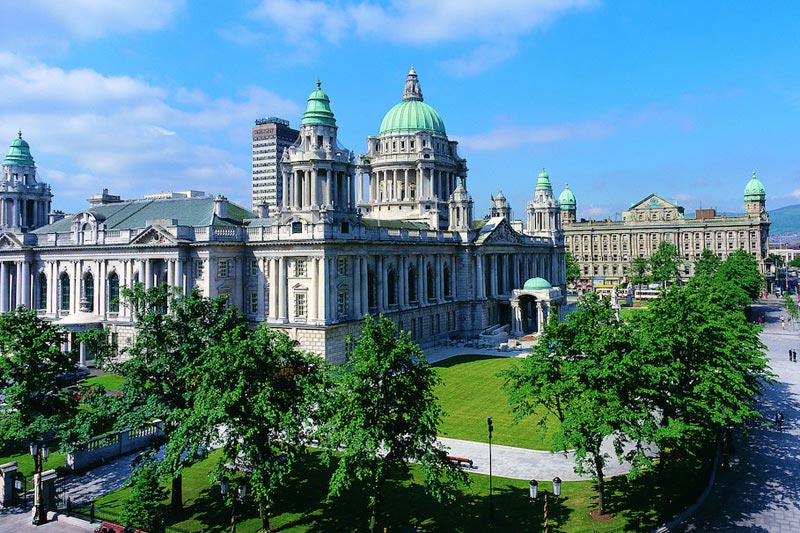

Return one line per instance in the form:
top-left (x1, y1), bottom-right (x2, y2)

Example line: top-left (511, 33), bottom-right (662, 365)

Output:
top-left (631, 274), bottom-right (771, 465)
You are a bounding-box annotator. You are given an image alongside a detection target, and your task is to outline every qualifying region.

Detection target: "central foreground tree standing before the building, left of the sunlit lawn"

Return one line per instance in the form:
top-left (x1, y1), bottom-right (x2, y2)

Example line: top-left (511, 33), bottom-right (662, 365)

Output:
top-left (321, 316), bottom-right (467, 532)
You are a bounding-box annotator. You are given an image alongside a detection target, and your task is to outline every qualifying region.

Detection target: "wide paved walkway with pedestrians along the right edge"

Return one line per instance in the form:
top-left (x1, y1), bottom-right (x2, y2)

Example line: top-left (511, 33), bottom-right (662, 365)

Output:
top-left (674, 299), bottom-right (800, 533)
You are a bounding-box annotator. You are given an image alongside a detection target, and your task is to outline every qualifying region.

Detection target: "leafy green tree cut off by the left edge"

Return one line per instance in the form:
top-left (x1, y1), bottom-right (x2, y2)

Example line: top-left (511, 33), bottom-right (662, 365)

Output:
top-left (0, 307), bottom-right (76, 444)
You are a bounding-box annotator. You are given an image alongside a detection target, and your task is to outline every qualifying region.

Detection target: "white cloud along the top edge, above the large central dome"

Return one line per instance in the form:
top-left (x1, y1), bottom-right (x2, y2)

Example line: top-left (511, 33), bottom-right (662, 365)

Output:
top-left (248, 0), bottom-right (598, 68)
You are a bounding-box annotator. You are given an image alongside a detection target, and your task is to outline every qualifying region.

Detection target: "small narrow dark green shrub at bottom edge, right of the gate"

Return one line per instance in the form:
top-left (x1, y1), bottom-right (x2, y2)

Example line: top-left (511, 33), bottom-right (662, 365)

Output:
top-left (119, 460), bottom-right (168, 532)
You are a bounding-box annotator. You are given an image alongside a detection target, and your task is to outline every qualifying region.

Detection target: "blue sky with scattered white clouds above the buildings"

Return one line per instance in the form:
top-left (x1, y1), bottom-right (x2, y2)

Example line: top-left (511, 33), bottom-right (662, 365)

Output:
top-left (0, 0), bottom-right (800, 219)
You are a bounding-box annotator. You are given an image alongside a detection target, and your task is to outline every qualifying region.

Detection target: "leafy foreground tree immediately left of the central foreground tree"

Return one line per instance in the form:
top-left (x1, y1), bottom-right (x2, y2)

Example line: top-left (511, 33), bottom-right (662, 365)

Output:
top-left (180, 324), bottom-right (329, 531)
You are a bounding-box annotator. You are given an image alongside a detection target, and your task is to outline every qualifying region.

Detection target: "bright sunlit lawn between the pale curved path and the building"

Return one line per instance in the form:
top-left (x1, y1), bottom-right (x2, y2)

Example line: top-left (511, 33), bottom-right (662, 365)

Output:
top-left (432, 355), bottom-right (557, 450)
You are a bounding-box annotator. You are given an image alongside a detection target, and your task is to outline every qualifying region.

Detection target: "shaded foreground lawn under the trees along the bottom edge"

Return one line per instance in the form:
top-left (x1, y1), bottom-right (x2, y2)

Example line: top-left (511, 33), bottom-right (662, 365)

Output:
top-left (89, 444), bottom-right (708, 533)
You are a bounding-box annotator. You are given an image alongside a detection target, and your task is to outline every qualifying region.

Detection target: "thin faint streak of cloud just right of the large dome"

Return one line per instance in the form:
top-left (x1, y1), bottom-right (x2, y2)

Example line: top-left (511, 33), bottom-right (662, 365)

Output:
top-left (455, 121), bottom-right (612, 150)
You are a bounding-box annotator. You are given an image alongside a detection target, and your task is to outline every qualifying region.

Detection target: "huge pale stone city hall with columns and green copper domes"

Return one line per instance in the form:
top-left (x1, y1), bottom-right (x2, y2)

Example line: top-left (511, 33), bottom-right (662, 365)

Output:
top-left (0, 69), bottom-right (565, 363)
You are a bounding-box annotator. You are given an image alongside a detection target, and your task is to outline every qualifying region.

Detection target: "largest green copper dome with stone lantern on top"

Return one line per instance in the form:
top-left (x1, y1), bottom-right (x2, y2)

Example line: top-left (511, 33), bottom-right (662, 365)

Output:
top-left (380, 67), bottom-right (447, 136)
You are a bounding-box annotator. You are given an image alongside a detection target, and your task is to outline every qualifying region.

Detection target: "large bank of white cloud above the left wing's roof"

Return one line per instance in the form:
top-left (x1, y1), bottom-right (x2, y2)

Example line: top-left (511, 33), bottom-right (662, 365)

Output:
top-left (0, 53), bottom-right (299, 211)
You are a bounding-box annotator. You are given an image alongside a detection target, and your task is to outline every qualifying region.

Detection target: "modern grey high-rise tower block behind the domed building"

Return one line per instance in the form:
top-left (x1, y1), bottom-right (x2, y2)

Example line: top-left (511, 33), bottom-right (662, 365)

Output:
top-left (253, 117), bottom-right (300, 209)
